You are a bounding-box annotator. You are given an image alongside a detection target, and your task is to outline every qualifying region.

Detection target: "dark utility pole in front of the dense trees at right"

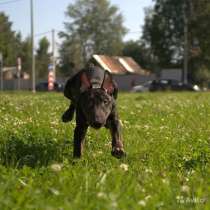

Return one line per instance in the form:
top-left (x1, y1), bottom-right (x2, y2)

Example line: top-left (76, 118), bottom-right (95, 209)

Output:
top-left (183, 0), bottom-right (189, 84)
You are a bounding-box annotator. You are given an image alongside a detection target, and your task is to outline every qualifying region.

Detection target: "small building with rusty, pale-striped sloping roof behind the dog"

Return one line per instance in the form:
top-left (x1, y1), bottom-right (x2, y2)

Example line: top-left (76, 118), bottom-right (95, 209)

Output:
top-left (90, 55), bottom-right (155, 91)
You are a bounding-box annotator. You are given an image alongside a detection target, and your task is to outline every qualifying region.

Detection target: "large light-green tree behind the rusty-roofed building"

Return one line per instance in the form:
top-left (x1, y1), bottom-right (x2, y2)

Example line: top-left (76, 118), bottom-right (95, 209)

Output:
top-left (60, 0), bottom-right (126, 75)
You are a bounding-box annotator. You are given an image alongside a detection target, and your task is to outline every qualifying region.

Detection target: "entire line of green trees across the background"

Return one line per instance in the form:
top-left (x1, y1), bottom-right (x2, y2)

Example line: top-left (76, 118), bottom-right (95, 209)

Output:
top-left (0, 0), bottom-right (210, 83)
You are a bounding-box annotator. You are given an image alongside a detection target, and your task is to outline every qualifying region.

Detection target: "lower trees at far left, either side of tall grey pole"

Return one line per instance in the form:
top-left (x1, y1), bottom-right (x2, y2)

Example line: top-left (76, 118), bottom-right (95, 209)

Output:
top-left (0, 12), bottom-right (50, 78)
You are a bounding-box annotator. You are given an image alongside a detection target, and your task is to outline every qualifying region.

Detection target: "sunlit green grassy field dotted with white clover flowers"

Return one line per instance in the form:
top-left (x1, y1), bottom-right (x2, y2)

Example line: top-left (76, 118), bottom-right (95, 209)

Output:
top-left (0, 93), bottom-right (210, 210)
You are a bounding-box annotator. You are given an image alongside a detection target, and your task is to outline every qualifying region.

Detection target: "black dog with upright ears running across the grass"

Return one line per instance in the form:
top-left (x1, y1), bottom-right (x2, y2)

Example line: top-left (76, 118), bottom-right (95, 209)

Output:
top-left (62, 66), bottom-right (125, 158)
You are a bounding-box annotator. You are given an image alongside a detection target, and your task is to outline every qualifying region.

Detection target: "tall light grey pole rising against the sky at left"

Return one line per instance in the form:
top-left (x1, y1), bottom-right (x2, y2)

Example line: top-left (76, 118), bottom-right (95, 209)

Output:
top-left (30, 0), bottom-right (36, 93)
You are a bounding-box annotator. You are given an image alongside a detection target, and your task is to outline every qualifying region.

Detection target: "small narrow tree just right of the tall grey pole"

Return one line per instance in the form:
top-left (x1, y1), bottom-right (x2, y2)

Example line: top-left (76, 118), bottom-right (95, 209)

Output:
top-left (36, 37), bottom-right (50, 79)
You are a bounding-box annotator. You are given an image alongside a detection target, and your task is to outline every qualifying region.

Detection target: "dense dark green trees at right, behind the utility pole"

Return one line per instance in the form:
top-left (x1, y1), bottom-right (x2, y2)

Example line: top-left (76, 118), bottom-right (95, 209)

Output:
top-left (142, 0), bottom-right (210, 80)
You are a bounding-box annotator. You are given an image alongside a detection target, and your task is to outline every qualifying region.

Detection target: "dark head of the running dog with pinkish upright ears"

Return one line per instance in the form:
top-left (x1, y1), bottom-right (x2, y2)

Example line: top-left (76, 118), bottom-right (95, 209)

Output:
top-left (79, 72), bottom-right (115, 129)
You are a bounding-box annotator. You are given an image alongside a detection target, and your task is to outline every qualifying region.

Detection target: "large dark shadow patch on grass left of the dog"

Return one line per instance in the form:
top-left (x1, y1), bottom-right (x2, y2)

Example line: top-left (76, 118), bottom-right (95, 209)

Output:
top-left (0, 136), bottom-right (72, 168)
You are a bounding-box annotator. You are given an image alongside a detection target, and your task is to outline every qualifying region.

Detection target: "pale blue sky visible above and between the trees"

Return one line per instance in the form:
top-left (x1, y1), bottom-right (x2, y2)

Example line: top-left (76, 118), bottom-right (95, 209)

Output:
top-left (0, 0), bottom-right (153, 48)
